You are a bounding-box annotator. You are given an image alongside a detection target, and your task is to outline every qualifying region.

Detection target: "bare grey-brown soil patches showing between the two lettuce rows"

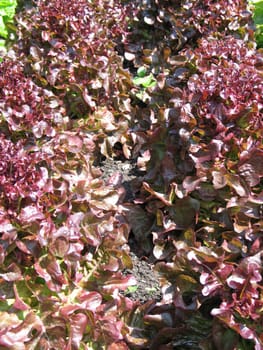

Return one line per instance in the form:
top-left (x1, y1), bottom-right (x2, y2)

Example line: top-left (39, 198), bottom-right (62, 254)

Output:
top-left (99, 159), bottom-right (162, 303)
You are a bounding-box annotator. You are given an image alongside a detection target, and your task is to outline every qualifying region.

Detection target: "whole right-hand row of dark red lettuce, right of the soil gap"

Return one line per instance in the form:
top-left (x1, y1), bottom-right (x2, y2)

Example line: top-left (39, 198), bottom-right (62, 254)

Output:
top-left (124, 2), bottom-right (263, 349)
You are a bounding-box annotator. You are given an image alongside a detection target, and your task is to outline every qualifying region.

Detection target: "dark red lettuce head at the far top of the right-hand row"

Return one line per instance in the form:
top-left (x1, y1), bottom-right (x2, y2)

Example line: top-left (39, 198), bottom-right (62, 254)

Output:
top-left (125, 0), bottom-right (253, 73)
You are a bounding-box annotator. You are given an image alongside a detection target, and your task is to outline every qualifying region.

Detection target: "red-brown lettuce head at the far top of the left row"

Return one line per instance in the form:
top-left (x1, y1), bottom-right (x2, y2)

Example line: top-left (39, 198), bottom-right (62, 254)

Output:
top-left (12, 0), bottom-right (133, 156)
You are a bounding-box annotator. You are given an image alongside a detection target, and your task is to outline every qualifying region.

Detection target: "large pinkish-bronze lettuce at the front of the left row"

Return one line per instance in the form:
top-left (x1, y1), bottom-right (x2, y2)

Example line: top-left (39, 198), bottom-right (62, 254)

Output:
top-left (0, 131), bottom-right (139, 349)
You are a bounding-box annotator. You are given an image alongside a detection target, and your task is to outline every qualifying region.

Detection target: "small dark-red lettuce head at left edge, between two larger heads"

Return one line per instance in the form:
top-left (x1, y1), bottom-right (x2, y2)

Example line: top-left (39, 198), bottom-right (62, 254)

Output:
top-left (0, 58), bottom-right (66, 139)
